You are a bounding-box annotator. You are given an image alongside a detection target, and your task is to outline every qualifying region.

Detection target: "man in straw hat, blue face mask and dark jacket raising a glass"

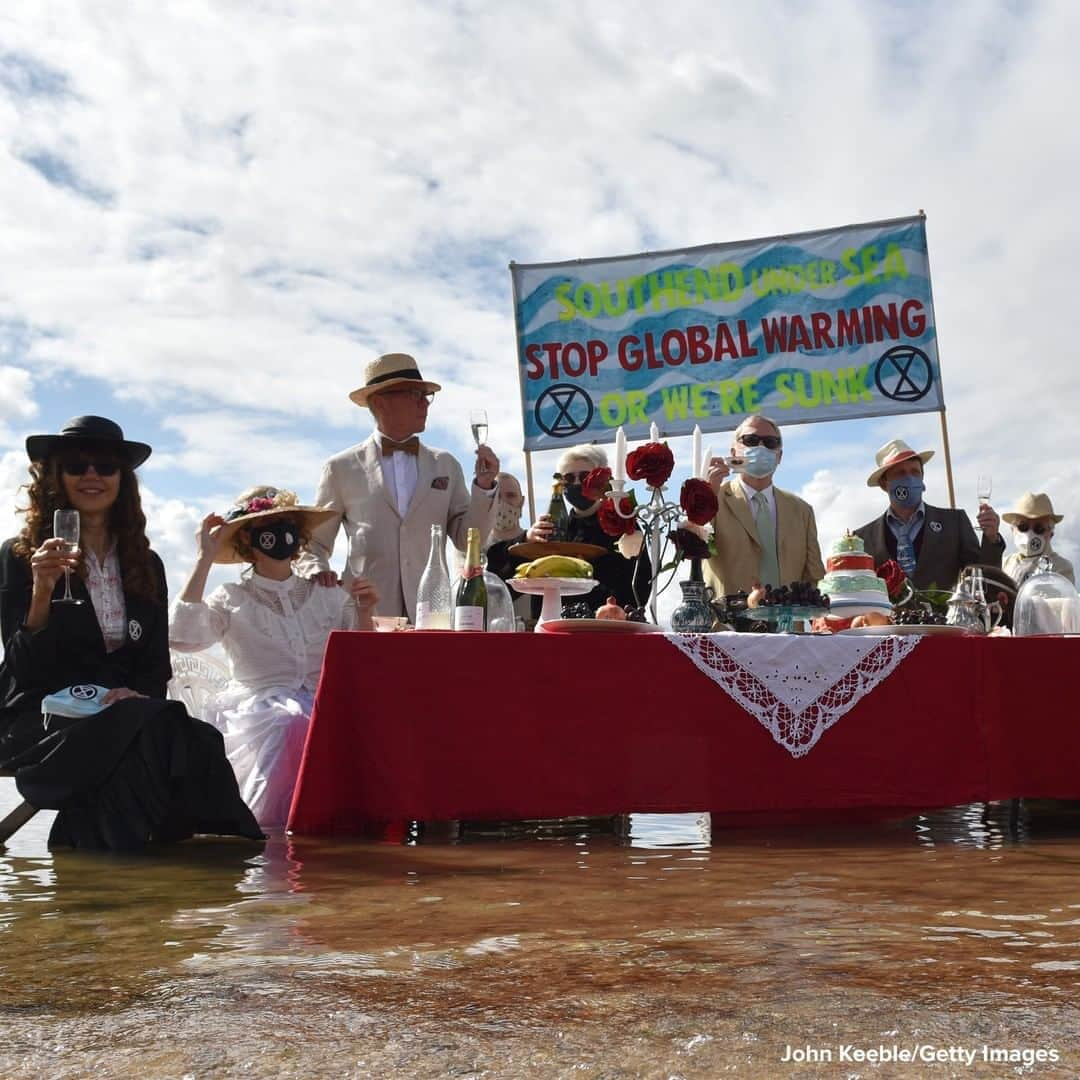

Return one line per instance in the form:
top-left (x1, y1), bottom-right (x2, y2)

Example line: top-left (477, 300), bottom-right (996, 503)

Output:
top-left (855, 438), bottom-right (1005, 589)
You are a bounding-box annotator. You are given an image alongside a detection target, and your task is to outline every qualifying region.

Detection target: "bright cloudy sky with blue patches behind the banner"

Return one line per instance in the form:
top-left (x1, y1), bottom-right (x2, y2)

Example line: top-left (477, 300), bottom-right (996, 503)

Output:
top-left (0, 0), bottom-right (1080, 608)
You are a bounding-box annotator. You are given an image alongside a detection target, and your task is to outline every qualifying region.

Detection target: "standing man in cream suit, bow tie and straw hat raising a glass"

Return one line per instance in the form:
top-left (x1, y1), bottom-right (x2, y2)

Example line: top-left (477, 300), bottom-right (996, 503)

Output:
top-left (298, 352), bottom-right (499, 621)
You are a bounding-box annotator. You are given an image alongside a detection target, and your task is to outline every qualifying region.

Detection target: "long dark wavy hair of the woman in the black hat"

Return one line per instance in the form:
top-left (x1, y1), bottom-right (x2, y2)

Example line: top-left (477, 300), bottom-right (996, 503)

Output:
top-left (14, 455), bottom-right (161, 600)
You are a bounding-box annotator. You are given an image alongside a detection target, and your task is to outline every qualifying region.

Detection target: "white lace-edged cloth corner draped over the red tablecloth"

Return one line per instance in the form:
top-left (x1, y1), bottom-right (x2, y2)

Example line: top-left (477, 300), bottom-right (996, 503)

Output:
top-left (664, 633), bottom-right (922, 757)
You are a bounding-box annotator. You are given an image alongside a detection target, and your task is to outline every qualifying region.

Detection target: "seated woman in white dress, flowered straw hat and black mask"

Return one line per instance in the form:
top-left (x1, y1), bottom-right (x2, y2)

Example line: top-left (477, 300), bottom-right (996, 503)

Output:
top-left (168, 487), bottom-right (377, 828)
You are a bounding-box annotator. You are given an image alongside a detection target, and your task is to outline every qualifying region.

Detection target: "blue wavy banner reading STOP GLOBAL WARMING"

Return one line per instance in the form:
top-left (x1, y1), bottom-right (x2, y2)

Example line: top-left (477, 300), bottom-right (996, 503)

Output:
top-left (512, 218), bottom-right (944, 449)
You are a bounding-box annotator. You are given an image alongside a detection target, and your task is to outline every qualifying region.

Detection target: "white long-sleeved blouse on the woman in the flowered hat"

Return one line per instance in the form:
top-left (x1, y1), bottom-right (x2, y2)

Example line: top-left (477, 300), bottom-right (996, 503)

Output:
top-left (168, 573), bottom-right (356, 693)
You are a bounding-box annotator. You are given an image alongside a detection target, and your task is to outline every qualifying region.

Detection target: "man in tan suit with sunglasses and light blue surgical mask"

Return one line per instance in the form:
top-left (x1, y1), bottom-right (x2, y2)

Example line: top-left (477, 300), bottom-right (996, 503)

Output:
top-left (705, 415), bottom-right (825, 596)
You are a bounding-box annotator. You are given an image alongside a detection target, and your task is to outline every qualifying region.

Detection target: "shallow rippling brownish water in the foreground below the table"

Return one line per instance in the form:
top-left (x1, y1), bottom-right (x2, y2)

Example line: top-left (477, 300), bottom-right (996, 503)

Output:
top-left (0, 789), bottom-right (1080, 1077)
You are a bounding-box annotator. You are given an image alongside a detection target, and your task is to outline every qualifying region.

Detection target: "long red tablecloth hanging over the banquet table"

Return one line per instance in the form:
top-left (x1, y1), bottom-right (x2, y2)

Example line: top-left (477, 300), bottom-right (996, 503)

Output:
top-left (289, 633), bottom-right (1080, 834)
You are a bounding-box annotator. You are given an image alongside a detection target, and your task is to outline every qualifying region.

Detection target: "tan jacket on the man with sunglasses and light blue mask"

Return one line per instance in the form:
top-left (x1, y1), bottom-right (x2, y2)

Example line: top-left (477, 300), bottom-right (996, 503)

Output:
top-left (705, 477), bottom-right (825, 596)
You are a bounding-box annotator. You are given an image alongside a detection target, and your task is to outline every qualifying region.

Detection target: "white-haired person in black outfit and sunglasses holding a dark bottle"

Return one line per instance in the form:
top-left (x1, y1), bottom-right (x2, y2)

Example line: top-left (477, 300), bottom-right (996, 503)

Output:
top-left (488, 444), bottom-right (652, 613)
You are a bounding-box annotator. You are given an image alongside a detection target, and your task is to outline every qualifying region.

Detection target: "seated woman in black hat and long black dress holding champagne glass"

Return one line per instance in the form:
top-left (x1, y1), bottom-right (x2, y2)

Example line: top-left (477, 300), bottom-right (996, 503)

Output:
top-left (0, 416), bottom-right (262, 851)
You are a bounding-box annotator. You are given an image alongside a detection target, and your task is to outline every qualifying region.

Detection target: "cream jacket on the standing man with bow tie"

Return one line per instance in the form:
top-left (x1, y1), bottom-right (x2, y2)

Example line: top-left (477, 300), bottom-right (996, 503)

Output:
top-left (297, 435), bottom-right (495, 621)
